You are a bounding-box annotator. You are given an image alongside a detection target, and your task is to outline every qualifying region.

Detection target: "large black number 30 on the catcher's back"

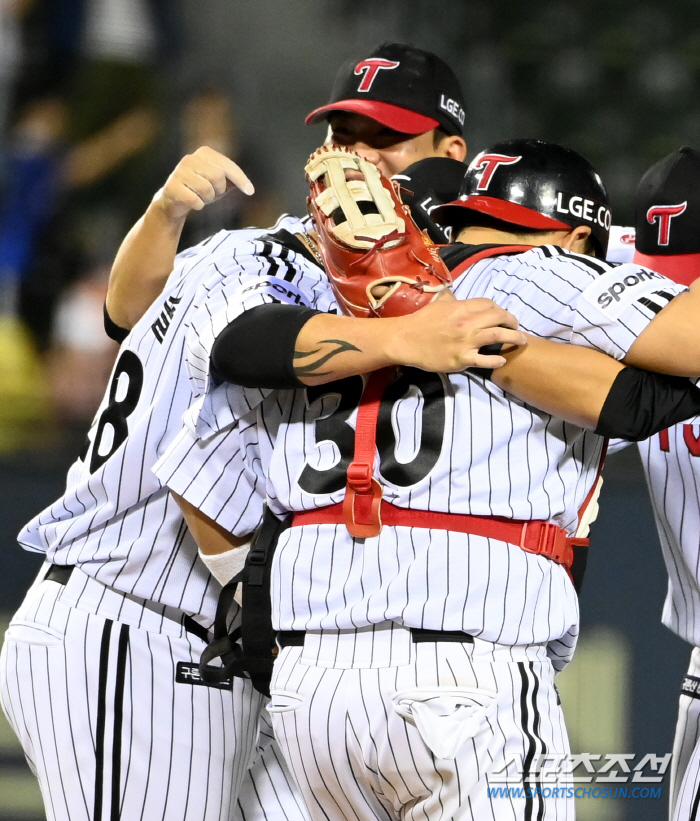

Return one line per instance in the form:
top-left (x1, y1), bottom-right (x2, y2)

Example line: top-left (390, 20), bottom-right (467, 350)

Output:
top-left (298, 368), bottom-right (445, 494)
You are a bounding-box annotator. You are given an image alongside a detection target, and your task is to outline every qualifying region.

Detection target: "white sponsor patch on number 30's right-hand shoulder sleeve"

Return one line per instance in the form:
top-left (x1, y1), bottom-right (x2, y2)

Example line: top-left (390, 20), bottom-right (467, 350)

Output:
top-left (581, 264), bottom-right (679, 320)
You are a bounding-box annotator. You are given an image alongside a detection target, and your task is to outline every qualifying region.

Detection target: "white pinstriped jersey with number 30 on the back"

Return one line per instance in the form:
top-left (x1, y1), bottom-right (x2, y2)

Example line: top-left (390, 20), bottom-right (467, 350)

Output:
top-left (159, 246), bottom-right (682, 644)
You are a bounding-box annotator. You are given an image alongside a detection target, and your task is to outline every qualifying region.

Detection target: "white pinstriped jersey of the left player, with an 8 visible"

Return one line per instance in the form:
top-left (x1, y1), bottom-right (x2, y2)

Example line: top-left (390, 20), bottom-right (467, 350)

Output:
top-left (19, 217), bottom-right (303, 621)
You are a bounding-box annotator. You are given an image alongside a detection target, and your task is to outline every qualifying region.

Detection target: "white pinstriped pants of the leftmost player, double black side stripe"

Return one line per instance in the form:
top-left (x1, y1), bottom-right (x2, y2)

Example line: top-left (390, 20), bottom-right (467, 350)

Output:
top-left (0, 569), bottom-right (304, 821)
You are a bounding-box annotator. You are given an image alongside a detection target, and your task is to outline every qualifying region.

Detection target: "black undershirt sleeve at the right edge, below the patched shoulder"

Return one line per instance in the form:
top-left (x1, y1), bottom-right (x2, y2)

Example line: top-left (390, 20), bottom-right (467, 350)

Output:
top-left (595, 366), bottom-right (700, 442)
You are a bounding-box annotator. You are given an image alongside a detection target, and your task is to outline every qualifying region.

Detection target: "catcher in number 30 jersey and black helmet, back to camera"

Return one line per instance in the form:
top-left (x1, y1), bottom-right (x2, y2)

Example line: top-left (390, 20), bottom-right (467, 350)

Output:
top-left (149, 141), bottom-right (698, 819)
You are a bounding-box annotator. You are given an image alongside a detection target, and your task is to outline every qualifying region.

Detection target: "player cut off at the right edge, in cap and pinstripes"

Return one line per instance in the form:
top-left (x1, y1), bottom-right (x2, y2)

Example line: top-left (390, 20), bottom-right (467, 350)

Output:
top-left (600, 147), bottom-right (700, 821)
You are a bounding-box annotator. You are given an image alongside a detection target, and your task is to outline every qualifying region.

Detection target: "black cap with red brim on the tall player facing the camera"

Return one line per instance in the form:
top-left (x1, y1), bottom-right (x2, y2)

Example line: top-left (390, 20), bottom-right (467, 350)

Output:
top-left (306, 43), bottom-right (464, 135)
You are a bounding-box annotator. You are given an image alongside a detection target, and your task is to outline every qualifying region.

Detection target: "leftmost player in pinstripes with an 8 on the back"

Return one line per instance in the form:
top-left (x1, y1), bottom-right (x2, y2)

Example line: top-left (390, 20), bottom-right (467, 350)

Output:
top-left (2, 186), bottom-right (519, 819)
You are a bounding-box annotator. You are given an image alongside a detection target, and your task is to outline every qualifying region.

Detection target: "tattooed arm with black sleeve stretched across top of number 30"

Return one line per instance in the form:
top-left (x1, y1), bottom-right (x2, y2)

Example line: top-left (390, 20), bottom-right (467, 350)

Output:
top-left (211, 299), bottom-right (526, 389)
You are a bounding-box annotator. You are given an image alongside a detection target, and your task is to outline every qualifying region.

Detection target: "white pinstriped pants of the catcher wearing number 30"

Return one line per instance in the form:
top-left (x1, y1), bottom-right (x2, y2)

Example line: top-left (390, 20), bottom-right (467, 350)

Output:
top-left (268, 623), bottom-right (574, 821)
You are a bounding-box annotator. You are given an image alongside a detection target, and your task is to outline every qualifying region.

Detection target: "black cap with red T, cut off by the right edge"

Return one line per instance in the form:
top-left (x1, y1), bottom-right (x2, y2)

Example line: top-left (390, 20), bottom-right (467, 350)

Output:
top-left (634, 146), bottom-right (700, 285)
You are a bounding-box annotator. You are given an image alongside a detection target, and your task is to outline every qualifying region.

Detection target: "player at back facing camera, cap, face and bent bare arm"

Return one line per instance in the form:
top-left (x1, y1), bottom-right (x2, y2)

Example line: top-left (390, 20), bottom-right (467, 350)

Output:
top-left (107, 43), bottom-right (467, 320)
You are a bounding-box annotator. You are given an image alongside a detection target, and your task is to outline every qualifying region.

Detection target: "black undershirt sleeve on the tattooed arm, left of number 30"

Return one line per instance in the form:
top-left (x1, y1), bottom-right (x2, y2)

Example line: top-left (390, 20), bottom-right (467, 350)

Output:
top-left (211, 305), bottom-right (320, 390)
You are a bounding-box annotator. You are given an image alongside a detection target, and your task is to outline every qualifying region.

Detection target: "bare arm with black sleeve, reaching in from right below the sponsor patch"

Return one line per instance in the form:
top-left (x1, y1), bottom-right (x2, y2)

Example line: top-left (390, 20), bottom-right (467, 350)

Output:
top-left (492, 336), bottom-right (700, 441)
